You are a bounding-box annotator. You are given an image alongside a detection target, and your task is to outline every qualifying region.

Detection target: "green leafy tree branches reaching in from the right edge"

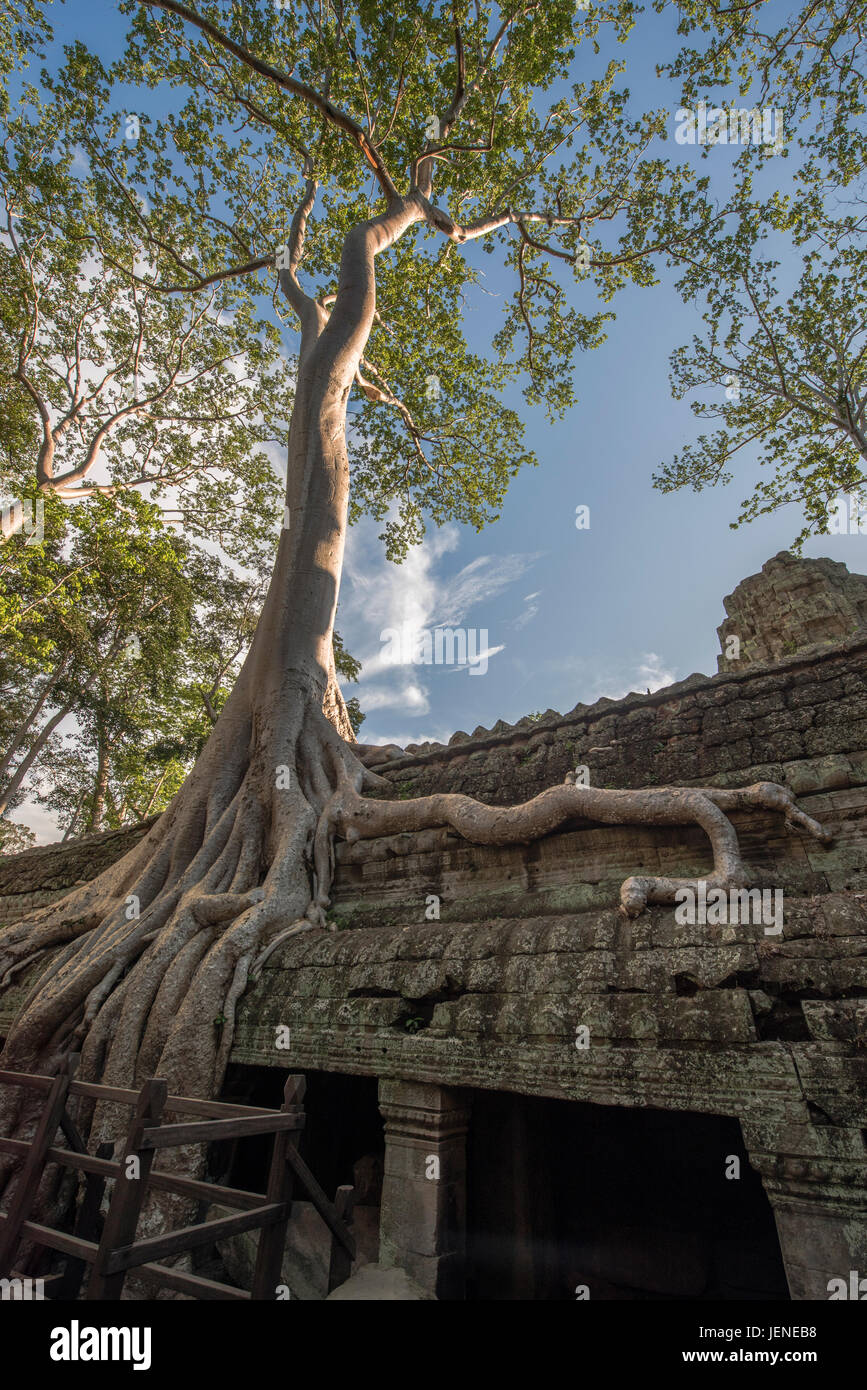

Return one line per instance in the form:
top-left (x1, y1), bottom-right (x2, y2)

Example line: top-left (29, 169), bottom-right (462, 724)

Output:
top-left (654, 0), bottom-right (867, 549)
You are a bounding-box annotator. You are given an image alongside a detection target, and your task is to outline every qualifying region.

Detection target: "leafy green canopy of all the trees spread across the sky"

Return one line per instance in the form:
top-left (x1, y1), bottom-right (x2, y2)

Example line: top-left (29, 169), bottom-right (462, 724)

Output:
top-left (0, 0), bottom-right (867, 833)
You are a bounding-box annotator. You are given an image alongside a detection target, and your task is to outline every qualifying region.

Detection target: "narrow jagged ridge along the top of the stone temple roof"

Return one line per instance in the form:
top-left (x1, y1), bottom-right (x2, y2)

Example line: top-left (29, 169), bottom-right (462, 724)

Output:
top-left (377, 628), bottom-right (867, 776)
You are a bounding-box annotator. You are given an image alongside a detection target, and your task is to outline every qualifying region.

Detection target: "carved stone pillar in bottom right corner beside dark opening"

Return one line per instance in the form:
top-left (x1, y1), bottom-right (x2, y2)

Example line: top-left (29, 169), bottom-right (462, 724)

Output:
top-left (742, 1123), bottom-right (867, 1301)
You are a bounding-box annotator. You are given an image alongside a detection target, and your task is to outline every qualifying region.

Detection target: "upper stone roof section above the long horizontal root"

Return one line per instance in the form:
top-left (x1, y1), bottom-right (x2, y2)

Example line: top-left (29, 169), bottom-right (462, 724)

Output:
top-left (366, 631), bottom-right (867, 805)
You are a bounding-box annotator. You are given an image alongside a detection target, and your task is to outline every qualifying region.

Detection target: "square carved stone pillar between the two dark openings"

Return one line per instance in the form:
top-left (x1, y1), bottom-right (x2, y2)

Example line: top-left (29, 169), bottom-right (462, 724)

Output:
top-left (379, 1079), bottom-right (470, 1298)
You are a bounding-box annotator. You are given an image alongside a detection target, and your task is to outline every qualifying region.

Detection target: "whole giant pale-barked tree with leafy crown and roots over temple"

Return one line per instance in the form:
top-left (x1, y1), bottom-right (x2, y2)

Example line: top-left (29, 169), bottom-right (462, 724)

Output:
top-left (1, 0), bottom-right (823, 1217)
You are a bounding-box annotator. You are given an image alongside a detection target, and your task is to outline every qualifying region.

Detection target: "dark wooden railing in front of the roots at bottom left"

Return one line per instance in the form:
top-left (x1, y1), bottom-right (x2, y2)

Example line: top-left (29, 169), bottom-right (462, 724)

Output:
top-left (0, 1056), bottom-right (356, 1300)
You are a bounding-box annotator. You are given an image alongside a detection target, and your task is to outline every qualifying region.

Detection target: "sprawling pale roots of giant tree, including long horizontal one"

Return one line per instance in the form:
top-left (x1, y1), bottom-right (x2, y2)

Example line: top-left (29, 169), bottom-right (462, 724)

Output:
top-left (0, 709), bottom-right (828, 1251)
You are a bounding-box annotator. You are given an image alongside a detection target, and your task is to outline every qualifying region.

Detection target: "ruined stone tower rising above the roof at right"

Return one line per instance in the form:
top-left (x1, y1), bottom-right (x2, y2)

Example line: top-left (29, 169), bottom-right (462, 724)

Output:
top-left (717, 550), bottom-right (867, 671)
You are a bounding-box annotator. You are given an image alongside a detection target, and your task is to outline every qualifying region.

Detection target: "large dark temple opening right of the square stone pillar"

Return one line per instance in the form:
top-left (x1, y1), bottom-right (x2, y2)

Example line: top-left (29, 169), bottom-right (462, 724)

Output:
top-left (467, 1091), bottom-right (789, 1301)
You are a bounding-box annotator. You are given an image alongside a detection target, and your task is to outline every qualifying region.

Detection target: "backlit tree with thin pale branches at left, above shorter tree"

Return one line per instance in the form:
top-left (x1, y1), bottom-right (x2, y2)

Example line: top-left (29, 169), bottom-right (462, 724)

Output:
top-left (0, 50), bottom-right (361, 730)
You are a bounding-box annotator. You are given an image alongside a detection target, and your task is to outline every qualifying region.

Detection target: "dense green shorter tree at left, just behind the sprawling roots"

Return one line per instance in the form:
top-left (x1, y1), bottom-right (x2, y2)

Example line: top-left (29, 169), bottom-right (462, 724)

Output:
top-left (0, 493), bottom-right (193, 830)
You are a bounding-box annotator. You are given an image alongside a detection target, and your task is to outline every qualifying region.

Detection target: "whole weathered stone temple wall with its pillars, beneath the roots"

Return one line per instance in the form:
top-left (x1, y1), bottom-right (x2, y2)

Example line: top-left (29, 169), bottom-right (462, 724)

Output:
top-left (0, 619), bottom-right (867, 1298)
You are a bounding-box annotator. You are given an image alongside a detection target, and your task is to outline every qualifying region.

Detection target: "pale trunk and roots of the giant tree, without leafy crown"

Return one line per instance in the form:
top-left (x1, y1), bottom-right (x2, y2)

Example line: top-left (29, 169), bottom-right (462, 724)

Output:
top-left (0, 197), bottom-right (823, 1230)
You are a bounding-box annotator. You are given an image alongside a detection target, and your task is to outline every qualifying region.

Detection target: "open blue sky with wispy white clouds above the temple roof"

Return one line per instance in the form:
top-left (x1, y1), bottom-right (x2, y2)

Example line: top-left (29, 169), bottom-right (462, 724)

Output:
top-left (13, 0), bottom-right (867, 837)
